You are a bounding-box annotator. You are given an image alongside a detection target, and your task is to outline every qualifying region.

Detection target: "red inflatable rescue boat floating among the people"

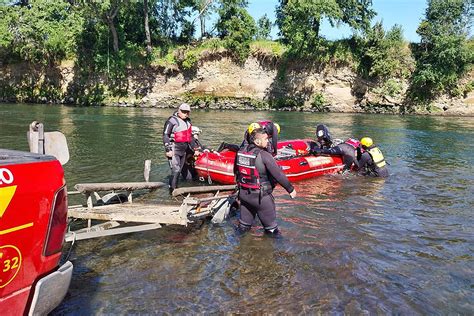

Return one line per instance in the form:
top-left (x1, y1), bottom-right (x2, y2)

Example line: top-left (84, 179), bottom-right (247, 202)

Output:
top-left (195, 139), bottom-right (344, 184)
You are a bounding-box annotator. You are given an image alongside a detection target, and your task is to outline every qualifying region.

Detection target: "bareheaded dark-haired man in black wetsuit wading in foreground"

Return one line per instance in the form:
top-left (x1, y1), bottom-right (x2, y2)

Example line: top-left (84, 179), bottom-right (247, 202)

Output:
top-left (234, 129), bottom-right (296, 236)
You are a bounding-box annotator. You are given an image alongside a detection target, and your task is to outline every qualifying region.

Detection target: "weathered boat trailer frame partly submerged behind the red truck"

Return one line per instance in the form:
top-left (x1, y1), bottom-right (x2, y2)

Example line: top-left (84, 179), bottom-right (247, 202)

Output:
top-left (65, 182), bottom-right (236, 242)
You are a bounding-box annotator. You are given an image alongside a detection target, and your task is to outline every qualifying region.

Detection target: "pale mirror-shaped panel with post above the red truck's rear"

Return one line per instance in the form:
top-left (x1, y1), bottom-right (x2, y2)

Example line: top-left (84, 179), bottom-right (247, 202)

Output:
top-left (27, 122), bottom-right (69, 165)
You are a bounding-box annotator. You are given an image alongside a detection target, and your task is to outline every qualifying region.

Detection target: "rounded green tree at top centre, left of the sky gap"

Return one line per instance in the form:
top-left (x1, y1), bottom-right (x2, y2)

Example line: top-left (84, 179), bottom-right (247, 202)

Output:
top-left (216, 0), bottom-right (257, 61)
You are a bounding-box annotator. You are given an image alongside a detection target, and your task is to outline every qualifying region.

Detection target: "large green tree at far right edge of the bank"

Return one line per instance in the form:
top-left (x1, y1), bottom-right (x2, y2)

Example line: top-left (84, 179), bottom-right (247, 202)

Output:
top-left (409, 0), bottom-right (474, 103)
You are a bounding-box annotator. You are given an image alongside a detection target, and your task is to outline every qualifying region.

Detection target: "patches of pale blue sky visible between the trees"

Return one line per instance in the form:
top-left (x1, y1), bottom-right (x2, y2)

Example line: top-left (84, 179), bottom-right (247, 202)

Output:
top-left (248, 0), bottom-right (427, 42)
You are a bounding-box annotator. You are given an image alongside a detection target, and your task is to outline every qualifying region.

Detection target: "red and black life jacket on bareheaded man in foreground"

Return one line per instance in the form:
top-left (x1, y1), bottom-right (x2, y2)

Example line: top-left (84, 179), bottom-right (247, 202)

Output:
top-left (235, 145), bottom-right (270, 190)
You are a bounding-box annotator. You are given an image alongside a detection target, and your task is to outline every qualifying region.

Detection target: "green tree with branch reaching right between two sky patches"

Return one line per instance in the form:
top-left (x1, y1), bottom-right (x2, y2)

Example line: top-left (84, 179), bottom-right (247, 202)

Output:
top-left (276, 0), bottom-right (375, 56)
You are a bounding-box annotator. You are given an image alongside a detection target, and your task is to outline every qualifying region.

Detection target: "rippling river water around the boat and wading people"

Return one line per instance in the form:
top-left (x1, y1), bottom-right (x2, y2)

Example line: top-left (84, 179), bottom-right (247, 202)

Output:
top-left (0, 104), bottom-right (474, 315)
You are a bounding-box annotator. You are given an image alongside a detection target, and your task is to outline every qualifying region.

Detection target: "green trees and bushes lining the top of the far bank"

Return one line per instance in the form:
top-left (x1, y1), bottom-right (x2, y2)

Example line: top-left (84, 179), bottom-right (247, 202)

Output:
top-left (0, 0), bottom-right (474, 108)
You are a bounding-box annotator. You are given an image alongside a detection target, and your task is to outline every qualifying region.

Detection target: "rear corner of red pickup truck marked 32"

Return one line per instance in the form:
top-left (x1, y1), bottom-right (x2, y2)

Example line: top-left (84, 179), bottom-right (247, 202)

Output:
top-left (0, 149), bottom-right (73, 315)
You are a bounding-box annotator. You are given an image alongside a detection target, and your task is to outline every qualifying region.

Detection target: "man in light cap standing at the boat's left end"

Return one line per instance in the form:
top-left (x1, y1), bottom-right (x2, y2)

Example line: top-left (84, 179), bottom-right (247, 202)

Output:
top-left (163, 103), bottom-right (192, 193)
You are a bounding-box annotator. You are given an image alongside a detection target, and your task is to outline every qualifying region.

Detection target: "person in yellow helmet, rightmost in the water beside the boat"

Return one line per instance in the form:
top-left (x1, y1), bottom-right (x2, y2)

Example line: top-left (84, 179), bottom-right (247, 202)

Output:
top-left (358, 137), bottom-right (389, 178)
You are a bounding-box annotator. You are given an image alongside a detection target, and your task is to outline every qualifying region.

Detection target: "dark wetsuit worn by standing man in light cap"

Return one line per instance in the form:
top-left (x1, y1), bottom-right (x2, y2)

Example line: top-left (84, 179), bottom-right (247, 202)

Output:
top-left (163, 113), bottom-right (191, 189)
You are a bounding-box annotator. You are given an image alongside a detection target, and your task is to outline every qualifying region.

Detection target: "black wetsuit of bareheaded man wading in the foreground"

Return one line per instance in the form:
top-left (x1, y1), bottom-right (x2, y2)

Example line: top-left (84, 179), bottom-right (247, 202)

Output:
top-left (234, 144), bottom-right (294, 231)
